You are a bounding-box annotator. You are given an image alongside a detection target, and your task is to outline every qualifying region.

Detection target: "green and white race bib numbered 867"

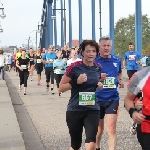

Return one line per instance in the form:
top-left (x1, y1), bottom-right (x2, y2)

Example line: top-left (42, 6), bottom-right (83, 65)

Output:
top-left (79, 92), bottom-right (95, 105)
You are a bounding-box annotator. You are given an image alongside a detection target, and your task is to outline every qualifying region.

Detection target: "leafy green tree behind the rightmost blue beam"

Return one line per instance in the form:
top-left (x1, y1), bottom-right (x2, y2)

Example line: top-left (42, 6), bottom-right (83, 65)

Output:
top-left (114, 15), bottom-right (150, 55)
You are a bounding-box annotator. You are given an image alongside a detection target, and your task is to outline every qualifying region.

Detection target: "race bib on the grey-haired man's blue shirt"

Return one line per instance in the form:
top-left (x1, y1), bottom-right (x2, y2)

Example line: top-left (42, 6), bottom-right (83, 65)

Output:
top-left (103, 77), bottom-right (116, 88)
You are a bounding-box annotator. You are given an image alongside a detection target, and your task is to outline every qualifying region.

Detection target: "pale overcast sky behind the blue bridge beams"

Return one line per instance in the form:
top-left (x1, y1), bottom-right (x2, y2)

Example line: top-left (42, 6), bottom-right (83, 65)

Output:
top-left (0, 0), bottom-right (150, 47)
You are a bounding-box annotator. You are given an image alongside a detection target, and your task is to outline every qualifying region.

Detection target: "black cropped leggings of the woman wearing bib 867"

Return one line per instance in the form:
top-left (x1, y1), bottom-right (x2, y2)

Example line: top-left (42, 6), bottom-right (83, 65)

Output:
top-left (66, 110), bottom-right (100, 150)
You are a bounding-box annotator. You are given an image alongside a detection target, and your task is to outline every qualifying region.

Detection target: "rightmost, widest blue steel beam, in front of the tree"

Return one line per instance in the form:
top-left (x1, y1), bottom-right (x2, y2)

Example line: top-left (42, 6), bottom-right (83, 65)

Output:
top-left (135, 0), bottom-right (142, 56)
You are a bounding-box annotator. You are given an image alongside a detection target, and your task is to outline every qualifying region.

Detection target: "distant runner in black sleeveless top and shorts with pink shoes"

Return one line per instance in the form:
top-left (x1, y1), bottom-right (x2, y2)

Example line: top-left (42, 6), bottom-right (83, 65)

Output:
top-left (35, 47), bottom-right (43, 85)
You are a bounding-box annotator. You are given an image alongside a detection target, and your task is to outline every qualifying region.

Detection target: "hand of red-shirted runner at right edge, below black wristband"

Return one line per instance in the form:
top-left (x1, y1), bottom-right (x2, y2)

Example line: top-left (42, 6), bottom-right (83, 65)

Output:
top-left (132, 111), bottom-right (145, 124)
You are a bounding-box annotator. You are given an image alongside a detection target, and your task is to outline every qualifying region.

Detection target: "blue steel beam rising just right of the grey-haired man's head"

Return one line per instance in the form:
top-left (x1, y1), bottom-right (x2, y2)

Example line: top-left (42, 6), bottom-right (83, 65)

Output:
top-left (109, 0), bottom-right (114, 54)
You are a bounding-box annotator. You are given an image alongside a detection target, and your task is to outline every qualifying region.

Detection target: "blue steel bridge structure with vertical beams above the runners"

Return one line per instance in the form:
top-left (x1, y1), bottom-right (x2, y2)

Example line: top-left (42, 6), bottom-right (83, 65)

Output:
top-left (40, 0), bottom-right (142, 54)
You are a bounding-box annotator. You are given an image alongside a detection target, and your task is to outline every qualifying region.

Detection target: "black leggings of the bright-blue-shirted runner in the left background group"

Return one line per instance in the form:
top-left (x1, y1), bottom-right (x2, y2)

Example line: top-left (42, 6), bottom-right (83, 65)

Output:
top-left (45, 67), bottom-right (54, 84)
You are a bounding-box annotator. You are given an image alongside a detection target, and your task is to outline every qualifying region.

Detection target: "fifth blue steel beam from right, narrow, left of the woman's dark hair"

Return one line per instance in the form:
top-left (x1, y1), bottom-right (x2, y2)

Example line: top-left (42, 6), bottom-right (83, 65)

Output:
top-left (68, 0), bottom-right (72, 48)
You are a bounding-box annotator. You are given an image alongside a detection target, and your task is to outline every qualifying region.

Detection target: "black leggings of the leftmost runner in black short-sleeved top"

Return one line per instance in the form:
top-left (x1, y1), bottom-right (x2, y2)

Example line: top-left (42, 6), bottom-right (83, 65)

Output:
top-left (19, 70), bottom-right (29, 87)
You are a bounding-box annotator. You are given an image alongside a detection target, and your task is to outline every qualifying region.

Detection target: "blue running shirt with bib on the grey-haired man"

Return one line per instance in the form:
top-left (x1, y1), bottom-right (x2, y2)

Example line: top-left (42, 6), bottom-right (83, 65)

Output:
top-left (95, 55), bottom-right (122, 101)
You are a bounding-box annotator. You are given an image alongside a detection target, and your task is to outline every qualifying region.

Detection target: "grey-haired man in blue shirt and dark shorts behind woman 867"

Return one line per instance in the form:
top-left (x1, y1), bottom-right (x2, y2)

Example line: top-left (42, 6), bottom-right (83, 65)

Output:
top-left (95, 37), bottom-right (124, 150)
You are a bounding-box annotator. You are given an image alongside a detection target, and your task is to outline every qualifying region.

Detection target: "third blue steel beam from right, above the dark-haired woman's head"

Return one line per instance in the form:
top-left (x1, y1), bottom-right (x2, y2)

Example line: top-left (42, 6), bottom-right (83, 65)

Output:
top-left (91, 0), bottom-right (96, 40)
